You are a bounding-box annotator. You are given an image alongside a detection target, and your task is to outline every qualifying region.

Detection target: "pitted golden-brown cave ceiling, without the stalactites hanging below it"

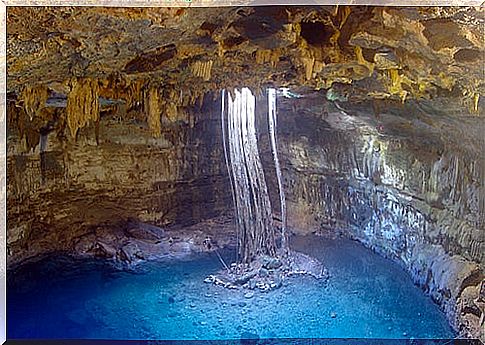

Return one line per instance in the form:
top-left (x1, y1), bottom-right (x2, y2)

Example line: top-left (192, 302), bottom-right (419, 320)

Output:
top-left (7, 6), bottom-right (485, 101)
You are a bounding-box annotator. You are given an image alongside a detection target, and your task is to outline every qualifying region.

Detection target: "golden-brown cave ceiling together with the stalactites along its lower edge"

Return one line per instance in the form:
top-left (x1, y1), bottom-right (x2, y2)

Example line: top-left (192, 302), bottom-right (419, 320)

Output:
top-left (7, 6), bottom-right (485, 151)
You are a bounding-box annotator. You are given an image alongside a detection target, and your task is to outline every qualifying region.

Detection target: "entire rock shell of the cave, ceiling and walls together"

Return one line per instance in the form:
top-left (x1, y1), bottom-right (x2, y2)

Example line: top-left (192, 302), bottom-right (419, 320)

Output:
top-left (7, 6), bottom-right (485, 339)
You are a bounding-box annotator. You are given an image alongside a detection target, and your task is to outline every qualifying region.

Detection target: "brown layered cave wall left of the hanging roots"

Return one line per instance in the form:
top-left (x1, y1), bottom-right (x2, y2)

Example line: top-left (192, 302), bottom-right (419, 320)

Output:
top-left (7, 95), bottom-right (231, 267)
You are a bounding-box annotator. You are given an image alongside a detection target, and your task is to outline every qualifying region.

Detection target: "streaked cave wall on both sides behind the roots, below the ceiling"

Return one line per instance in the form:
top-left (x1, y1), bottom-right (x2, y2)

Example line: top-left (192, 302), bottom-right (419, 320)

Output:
top-left (7, 84), bottom-right (485, 336)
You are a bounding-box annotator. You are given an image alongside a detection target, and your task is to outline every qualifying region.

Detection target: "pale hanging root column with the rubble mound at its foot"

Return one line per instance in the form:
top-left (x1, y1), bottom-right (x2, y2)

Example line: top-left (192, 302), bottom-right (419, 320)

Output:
top-left (204, 87), bottom-right (328, 296)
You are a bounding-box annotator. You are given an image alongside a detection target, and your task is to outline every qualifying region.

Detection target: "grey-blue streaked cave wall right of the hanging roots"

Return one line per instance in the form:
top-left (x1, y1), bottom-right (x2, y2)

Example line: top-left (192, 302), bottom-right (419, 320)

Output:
top-left (272, 97), bottom-right (485, 337)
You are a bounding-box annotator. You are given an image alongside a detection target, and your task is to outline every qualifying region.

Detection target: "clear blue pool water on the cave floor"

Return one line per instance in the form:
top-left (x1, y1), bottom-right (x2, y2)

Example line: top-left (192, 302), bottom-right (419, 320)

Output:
top-left (7, 237), bottom-right (454, 339)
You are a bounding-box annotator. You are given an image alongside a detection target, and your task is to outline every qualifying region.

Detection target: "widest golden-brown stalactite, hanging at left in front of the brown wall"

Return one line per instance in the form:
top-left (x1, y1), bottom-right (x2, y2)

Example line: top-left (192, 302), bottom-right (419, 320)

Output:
top-left (66, 78), bottom-right (99, 138)
